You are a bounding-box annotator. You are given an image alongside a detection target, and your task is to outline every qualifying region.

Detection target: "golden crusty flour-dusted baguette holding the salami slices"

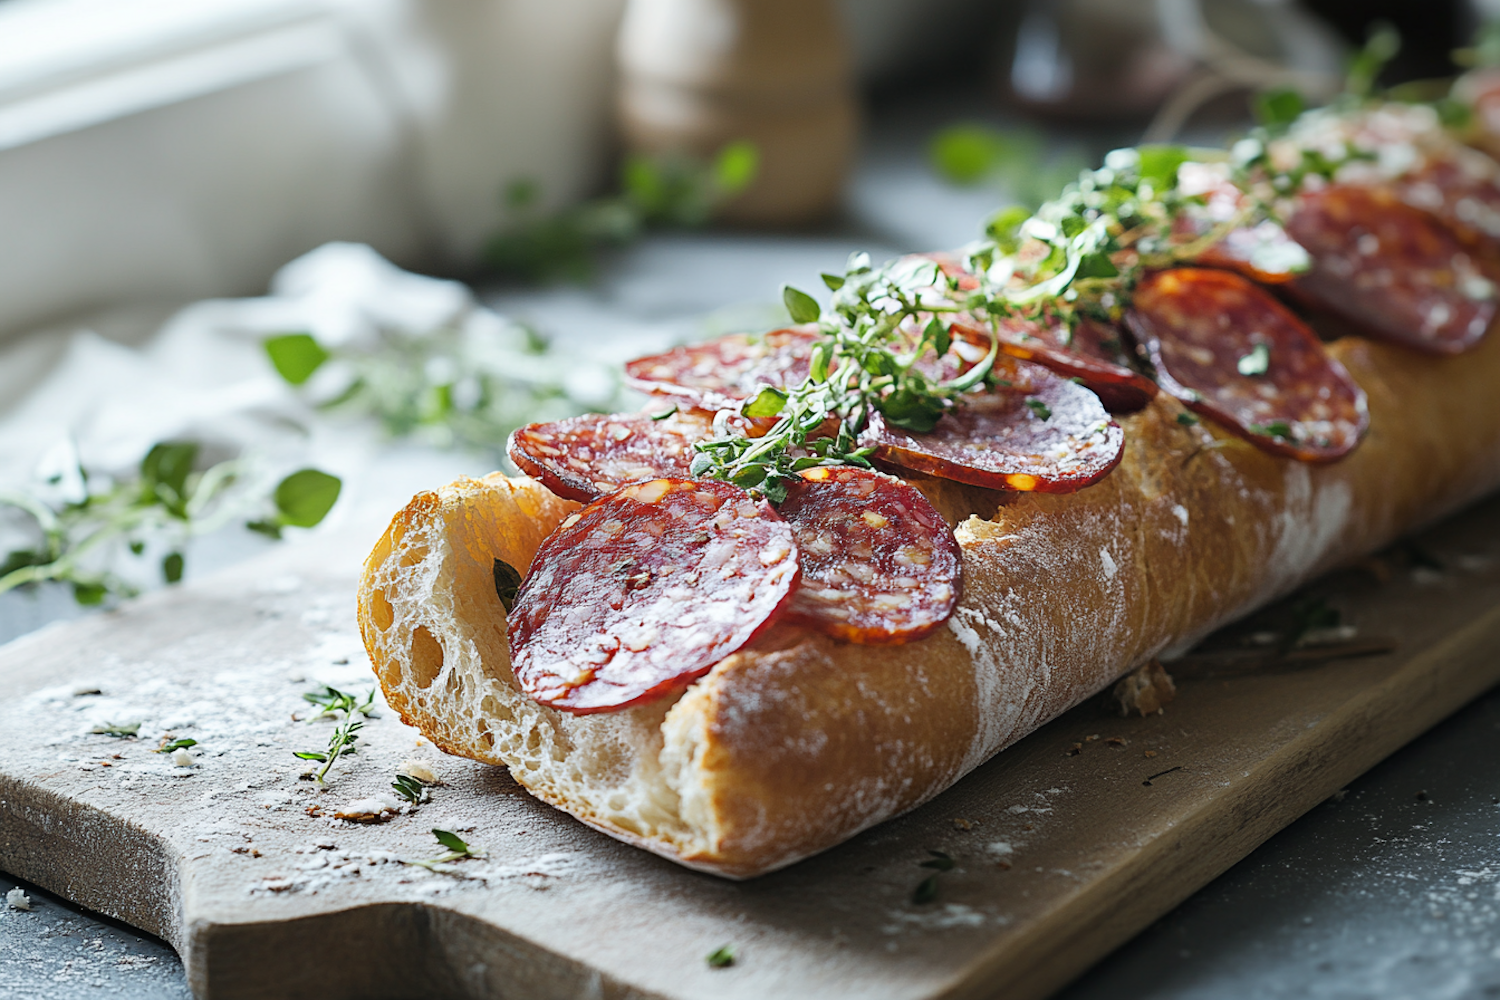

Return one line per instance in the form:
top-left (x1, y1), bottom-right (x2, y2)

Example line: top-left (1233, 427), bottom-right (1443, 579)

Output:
top-left (360, 326), bottom-right (1500, 877)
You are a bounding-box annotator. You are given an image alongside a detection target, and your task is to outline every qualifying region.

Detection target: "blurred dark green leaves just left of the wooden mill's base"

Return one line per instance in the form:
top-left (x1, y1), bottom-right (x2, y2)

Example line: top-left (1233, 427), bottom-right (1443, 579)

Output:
top-left (485, 141), bottom-right (761, 282)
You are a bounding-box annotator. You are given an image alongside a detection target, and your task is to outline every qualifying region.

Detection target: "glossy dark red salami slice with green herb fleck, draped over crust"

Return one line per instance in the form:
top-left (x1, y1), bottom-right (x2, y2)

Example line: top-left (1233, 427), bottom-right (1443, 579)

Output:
top-left (1128, 267), bottom-right (1370, 462)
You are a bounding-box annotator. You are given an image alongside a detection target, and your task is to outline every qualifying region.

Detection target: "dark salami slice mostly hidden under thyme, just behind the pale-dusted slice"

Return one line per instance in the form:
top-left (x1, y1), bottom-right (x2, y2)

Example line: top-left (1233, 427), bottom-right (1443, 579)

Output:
top-left (951, 318), bottom-right (1157, 414)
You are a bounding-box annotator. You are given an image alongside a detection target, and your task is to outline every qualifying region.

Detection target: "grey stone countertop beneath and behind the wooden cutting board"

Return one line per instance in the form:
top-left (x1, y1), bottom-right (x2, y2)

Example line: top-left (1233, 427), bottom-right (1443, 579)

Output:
top-left (0, 95), bottom-right (1500, 1000)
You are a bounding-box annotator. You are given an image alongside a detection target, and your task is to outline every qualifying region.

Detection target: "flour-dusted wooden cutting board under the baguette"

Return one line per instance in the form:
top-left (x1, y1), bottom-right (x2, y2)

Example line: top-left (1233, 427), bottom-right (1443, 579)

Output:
top-left (0, 491), bottom-right (1500, 1000)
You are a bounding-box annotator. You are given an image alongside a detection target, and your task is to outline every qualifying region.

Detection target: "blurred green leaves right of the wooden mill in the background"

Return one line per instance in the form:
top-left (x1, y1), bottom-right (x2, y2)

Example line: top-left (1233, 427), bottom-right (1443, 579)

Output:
top-left (927, 123), bottom-right (1088, 208)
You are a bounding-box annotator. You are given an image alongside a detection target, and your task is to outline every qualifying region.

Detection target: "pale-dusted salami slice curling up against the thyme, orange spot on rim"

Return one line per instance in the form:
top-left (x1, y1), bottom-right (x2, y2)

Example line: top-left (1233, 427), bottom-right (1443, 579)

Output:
top-left (866, 355), bottom-right (1125, 493)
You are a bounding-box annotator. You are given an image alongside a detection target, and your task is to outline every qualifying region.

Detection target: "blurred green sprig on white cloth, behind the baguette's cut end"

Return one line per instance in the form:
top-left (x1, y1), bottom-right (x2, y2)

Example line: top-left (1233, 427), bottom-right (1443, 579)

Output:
top-left (264, 310), bottom-right (620, 456)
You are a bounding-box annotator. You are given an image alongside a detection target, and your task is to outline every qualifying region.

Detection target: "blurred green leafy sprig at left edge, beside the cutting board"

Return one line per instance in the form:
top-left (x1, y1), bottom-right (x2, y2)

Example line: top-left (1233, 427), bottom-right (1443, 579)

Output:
top-left (0, 441), bottom-right (342, 604)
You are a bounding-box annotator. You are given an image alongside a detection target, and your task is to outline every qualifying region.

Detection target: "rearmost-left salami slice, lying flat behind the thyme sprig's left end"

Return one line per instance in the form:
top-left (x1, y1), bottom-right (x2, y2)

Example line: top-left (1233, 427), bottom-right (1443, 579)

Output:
top-left (626, 327), bottom-right (819, 409)
